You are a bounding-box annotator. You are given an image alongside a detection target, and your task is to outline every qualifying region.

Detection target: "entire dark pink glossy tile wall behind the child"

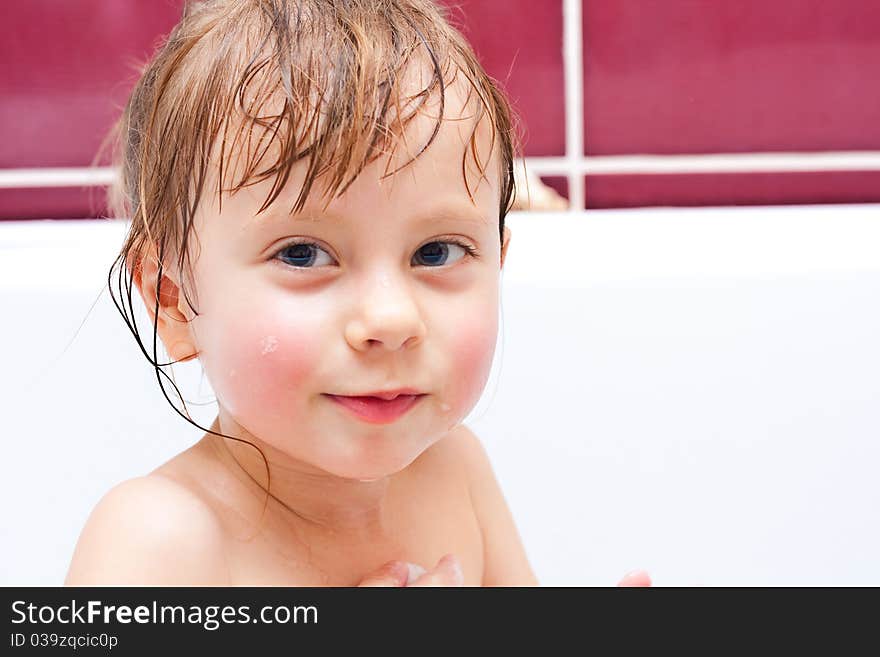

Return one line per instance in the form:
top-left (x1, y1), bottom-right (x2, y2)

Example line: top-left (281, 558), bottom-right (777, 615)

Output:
top-left (0, 0), bottom-right (880, 218)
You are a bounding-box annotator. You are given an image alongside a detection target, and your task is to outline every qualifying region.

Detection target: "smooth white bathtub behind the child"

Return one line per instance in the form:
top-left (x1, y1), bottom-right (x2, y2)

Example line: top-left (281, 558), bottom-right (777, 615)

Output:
top-left (0, 205), bottom-right (880, 585)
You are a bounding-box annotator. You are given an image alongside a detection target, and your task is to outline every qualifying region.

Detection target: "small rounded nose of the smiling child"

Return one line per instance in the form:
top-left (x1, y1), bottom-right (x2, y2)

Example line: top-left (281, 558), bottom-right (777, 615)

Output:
top-left (345, 272), bottom-right (426, 351)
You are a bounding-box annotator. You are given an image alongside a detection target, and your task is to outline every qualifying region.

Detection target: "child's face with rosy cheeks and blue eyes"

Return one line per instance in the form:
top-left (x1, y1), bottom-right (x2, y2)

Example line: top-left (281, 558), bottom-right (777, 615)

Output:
top-left (181, 92), bottom-right (510, 479)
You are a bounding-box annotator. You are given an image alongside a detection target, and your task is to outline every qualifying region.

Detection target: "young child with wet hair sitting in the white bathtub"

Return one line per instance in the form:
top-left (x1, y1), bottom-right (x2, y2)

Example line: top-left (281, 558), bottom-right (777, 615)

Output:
top-left (66, 0), bottom-right (648, 586)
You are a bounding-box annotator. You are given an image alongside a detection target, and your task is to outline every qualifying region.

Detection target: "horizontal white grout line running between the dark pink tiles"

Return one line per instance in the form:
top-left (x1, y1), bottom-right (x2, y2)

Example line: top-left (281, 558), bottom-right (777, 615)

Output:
top-left (0, 151), bottom-right (880, 190)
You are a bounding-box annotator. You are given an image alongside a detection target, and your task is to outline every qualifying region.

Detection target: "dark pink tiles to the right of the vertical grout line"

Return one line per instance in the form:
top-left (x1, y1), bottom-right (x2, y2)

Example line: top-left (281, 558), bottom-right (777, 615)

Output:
top-left (583, 0), bottom-right (880, 207)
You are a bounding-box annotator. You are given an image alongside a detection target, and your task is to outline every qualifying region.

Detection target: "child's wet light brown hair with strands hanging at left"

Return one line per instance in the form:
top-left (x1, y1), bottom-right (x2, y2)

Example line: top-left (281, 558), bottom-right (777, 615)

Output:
top-left (108, 0), bottom-right (517, 520)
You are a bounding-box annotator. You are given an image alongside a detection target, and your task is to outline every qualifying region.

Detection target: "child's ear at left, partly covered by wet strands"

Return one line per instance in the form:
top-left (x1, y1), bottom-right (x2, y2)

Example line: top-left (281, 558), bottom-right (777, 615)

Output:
top-left (132, 251), bottom-right (198, 362)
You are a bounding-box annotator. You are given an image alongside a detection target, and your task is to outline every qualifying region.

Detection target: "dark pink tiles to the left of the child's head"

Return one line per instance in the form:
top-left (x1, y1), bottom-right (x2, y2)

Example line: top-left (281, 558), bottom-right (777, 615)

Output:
top-left (0, 0), bottom-right (182, 219)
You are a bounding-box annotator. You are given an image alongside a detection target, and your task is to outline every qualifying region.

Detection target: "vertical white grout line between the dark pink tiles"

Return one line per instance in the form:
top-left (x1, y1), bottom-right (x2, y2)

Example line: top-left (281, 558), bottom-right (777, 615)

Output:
top-left (564, 0), bottom-right (584, 211)
